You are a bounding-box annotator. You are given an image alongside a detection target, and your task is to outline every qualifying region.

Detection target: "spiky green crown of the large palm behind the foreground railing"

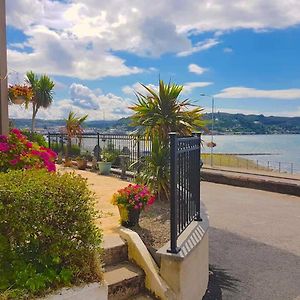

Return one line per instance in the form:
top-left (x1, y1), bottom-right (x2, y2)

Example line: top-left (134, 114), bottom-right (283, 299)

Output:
top-left (131, 80), bottom-right (204, 143)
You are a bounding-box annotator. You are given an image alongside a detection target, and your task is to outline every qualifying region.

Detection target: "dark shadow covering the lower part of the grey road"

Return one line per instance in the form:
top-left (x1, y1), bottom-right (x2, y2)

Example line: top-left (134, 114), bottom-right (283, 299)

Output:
top-left (203, 224), bottom-right (300, 300)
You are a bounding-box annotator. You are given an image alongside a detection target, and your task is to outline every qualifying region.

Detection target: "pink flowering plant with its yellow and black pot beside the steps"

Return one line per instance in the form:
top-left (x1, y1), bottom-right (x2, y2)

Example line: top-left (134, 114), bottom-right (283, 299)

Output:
top-left (112, 184), bottom-right (155, 227)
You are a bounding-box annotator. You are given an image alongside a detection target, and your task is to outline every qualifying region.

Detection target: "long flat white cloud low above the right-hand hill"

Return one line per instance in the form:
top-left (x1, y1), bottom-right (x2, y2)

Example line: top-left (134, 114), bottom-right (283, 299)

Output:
top-left (215, 87), bottom-right (300, 100)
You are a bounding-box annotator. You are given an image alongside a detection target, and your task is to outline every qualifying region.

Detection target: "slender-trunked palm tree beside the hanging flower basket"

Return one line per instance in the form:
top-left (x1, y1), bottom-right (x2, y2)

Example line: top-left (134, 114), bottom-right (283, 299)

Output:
top-left (26, 71), bottom-right (55, 133)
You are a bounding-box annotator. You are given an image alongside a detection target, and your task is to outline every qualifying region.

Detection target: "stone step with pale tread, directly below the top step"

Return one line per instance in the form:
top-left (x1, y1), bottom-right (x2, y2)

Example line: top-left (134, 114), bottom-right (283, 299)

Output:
top-left (104, 261), bottom-right (145, 300)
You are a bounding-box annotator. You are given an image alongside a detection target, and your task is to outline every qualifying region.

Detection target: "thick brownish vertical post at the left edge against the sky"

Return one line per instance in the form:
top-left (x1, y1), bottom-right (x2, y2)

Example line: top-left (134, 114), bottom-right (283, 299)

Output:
top-left (0, 0), bottom-right (9, 135)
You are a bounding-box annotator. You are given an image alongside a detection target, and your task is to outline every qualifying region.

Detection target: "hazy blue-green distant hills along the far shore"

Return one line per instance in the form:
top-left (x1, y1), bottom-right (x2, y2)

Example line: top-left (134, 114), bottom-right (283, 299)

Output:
top-left (13, 112), bottom-right (300, 134)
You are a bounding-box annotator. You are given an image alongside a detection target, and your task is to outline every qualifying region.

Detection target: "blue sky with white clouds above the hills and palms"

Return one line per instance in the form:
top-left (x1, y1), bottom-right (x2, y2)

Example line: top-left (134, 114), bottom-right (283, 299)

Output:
top-left (6, 0), bottom-right (300, 120)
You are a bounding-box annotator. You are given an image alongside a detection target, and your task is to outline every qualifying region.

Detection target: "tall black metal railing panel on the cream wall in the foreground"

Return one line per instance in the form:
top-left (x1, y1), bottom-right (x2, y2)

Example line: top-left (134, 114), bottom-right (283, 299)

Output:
top-left (168, 133), bottom-right (201, 253)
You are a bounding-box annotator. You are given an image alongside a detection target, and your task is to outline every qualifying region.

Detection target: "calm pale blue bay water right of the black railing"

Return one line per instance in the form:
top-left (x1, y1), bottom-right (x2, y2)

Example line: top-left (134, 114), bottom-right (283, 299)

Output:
top-left (203, 134), bottom-right (300, 173)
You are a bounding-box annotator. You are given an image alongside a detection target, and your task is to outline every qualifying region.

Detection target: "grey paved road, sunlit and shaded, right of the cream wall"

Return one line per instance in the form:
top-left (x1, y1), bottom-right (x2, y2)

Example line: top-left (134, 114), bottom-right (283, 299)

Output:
top-left (201, 182), bottom-right (300, 300)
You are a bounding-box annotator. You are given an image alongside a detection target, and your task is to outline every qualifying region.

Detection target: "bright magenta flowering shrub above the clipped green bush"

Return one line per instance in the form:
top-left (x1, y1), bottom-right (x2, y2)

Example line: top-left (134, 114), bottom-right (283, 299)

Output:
top-left (0, 129), bottom-right (56, 172)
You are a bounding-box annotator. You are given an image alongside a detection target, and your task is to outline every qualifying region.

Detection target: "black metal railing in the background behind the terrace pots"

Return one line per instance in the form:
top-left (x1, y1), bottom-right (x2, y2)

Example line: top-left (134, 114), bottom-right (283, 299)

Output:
top-left (47, 132), bottom-right (151, 166)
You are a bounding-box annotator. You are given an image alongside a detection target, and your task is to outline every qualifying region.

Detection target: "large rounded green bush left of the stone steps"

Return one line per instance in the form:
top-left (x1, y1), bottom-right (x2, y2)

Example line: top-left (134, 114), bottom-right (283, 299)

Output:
top-left (0, 170), bottom-right (102, 299)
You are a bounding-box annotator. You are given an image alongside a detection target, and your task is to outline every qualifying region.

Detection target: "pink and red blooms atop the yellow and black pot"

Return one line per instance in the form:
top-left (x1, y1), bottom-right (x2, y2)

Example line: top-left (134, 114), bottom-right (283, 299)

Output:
top-left (112, 184), bottom-right (155, 210)
